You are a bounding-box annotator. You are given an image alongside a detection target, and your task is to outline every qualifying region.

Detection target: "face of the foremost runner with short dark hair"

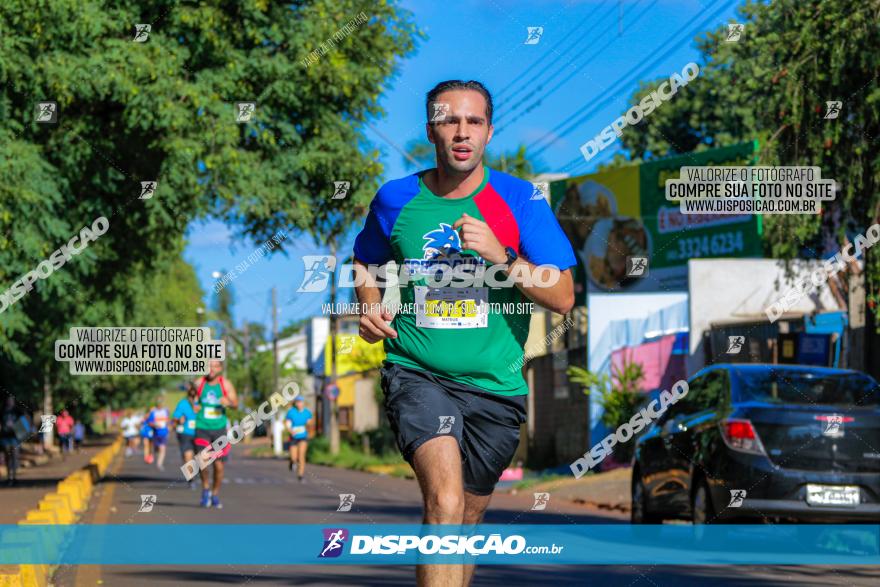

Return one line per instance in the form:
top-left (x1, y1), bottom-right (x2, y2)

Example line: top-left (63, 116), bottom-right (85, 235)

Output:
top-left (428, 90), bottom-right (492, 174)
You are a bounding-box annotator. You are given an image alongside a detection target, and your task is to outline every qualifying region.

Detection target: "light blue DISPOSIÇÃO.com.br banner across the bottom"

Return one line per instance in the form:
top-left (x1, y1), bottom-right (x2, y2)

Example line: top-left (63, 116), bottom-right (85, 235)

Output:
top-left (0, 524), bottom-right (880, 565)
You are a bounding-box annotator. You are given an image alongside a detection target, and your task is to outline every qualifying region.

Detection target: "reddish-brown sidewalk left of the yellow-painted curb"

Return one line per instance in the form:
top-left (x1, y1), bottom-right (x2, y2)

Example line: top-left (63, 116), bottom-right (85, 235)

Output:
top-left (0, 437), bottom-right (113, 524)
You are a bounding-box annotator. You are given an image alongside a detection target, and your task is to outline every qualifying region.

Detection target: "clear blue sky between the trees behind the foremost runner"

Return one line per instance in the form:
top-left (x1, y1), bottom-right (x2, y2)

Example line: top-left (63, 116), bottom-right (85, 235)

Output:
top-left (185, 0), bottom-right (740, 327)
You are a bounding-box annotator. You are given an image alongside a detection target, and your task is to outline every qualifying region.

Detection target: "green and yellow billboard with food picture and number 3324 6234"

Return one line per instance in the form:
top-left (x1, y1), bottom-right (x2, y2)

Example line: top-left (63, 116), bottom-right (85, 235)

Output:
top-left (550, 143), bottom-right (762, 293)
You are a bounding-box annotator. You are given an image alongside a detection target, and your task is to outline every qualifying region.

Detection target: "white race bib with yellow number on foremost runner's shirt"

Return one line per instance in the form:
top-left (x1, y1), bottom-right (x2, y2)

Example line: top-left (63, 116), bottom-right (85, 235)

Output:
top-left (414, 285), bottom-right (489, 328)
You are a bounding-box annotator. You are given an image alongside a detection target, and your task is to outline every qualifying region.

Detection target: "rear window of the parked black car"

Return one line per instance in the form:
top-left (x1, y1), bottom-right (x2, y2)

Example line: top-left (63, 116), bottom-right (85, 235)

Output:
top-left (739, 369), bottom-right (880, 406)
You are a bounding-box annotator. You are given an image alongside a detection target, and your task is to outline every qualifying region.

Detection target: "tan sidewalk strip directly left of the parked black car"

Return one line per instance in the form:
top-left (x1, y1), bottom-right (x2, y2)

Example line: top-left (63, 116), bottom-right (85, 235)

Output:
top-left (502, 467), bottom-right (632, 513)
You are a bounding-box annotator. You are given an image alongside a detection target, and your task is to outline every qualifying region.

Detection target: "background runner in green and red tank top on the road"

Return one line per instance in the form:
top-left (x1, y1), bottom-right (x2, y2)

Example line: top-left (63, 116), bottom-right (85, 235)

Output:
top-left (195, 361), bottom-right (238, 509)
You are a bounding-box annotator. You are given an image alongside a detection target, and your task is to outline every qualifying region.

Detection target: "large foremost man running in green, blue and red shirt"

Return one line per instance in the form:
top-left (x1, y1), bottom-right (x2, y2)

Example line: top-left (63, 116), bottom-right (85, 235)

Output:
top-left (354, 80), bottom-right (576, 585)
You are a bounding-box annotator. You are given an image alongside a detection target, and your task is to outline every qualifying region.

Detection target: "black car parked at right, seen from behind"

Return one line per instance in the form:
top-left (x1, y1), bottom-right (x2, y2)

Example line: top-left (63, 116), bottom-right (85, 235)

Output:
top-left (632, 364), bottom-right (880, 524)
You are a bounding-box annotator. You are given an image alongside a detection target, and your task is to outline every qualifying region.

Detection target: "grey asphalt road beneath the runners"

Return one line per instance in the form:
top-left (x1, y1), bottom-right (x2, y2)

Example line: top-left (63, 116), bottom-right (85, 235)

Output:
top-left (55, 444), bottom-right (880, 587)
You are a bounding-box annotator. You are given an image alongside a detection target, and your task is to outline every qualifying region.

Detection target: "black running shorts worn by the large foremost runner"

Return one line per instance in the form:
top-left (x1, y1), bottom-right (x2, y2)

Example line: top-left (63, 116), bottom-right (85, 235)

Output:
top-left (381, 361), bottom-right (526, 495)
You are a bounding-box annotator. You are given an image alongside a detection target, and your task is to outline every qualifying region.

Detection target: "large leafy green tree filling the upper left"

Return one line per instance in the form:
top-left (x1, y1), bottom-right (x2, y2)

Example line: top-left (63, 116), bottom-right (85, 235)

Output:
top-left (0, 0), bottom-right (420, 414)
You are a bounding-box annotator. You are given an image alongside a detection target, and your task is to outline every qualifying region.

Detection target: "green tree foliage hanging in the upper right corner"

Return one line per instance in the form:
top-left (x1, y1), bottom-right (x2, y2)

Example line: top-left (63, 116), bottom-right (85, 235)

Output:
top-left (622, 0), bottom-right (880, 325)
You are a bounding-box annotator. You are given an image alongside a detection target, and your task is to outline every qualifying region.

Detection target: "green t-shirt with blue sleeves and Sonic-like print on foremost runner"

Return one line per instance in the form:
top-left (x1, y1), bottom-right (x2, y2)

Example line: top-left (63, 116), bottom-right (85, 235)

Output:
top-left (354, 168), bottom-right (576, 395)
